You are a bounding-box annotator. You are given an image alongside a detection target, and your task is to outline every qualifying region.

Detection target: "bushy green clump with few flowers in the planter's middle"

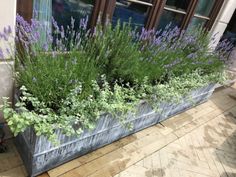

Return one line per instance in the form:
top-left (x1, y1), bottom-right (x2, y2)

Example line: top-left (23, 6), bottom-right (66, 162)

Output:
top-left (85, 23), bottom-right (144, 82)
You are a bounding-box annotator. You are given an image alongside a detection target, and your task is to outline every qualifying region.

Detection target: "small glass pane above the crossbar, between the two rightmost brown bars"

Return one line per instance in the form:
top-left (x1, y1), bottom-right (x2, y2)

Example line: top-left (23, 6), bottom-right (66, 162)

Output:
top-left (196, 0), bottom-right (215, 17)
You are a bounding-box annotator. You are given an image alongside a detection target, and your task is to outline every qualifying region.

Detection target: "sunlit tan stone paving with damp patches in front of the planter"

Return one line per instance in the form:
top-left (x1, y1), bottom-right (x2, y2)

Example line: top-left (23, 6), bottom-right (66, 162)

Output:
top-left (0, 85), bottom-right (236, 177)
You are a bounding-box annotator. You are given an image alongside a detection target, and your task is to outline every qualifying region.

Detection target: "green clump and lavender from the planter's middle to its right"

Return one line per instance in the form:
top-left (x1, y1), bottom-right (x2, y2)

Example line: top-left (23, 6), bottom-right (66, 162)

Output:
top-left (84, 22), bottom-right (224, 85)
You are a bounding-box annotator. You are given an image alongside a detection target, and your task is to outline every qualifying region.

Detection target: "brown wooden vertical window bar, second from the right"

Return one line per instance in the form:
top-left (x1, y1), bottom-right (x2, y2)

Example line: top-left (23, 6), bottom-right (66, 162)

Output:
top-left (180, 0), bottom-right (198, 29)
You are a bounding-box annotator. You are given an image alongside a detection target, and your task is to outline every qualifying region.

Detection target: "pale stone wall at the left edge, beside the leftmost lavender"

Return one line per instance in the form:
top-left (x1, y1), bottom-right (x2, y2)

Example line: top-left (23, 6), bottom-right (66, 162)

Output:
top-left (0, 0), bottom-right (16, 137)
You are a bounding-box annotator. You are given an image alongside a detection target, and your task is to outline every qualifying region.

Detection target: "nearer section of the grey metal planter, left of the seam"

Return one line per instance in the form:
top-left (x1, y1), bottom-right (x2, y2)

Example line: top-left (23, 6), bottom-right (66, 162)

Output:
top-left (18, 103), bottom-right (160, 176)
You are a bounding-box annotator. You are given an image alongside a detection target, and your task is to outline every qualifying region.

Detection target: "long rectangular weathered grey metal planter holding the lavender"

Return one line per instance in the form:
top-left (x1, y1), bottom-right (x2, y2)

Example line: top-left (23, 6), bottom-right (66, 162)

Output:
top-left (15, 84), bottom-right (215, 176)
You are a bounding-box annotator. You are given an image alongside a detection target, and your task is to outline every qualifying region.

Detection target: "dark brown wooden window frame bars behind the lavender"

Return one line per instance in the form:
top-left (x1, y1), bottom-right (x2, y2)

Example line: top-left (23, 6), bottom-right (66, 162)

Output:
top-left (17, 0), bottom-right (224, 31)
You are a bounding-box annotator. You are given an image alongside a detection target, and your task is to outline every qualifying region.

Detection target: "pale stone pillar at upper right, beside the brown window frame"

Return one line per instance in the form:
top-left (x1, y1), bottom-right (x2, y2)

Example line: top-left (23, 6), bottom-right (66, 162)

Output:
top-left (211, 0), bottom-right (236, 48)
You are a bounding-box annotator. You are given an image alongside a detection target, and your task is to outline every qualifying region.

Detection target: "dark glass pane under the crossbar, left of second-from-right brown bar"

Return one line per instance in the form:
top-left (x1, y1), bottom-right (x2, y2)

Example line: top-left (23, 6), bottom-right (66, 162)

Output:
top-left (157, 10), bottom-right (184, 30)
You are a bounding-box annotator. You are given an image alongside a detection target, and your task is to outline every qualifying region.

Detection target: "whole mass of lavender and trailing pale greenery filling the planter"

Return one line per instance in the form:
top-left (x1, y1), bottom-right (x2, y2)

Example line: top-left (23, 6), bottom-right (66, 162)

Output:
top-left (0, 16), bottom-right (230, 141)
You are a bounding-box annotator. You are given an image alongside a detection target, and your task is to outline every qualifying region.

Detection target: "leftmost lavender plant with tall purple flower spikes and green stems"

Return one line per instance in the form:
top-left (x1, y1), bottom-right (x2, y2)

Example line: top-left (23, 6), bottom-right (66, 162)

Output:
top-left (15, 16), bottom-right (98, 109)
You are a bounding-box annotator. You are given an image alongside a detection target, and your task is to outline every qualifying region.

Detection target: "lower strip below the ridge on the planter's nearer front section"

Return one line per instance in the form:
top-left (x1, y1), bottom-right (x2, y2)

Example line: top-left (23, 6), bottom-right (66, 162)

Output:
top-left (33, 113), bottom-right (158, 175)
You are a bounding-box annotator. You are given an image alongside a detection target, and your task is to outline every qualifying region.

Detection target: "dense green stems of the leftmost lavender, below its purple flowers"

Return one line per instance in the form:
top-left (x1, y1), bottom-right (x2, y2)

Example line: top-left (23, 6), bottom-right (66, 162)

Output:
top-left (16, 51), bottom-right (98, 109)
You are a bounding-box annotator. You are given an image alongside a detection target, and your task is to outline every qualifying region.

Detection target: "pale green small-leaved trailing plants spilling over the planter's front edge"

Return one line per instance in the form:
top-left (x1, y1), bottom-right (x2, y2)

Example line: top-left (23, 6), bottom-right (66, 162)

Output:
top-left (0, 71), bottom-right (228, 143)
